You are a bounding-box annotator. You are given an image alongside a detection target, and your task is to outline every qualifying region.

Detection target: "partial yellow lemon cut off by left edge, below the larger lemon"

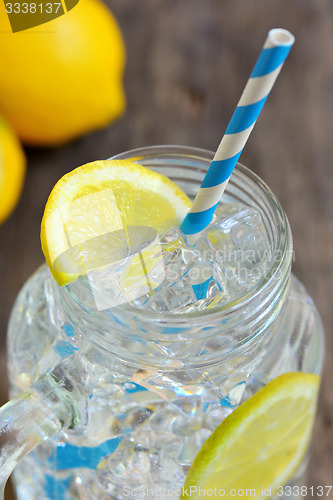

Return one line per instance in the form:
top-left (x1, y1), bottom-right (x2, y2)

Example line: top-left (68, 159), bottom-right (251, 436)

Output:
top-left (0, 118), bottom-right (26, 224)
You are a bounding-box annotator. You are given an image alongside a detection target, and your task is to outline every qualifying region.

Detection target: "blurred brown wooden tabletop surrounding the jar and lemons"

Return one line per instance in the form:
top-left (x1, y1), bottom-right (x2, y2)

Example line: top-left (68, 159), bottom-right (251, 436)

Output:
top-left (0, 0), bottom-right (333, 499)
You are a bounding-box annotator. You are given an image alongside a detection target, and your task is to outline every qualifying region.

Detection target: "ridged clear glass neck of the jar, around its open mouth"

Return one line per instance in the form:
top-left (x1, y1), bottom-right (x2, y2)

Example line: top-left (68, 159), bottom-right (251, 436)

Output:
top-left (56, 146), bottom-right (292, 366)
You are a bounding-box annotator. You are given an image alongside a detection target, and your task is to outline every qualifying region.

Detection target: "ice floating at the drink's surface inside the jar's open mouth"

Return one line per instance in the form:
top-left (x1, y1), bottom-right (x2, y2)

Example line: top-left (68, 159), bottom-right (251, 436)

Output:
top-left (93, 203), bottom-right (270, 314)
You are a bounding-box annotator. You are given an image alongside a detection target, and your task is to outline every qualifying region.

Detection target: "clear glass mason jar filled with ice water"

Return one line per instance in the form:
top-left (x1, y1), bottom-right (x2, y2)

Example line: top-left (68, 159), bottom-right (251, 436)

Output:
top-left (8, 146), bottom-right (324, 500)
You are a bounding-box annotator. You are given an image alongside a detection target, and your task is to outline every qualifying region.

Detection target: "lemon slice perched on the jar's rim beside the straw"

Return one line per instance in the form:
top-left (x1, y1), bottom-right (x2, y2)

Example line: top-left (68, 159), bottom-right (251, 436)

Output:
top-left (41, 160), bottom-right (191, 285)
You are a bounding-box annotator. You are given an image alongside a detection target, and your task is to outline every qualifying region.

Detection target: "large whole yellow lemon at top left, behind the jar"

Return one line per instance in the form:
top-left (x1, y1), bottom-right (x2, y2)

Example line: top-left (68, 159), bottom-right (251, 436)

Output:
top-left (0, 0), bottom-right (125, 146)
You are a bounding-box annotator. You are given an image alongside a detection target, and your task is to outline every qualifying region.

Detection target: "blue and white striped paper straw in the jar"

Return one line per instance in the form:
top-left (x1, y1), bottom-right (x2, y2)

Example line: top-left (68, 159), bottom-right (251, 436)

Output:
top-left (181, 28), bottom-right (295, 234)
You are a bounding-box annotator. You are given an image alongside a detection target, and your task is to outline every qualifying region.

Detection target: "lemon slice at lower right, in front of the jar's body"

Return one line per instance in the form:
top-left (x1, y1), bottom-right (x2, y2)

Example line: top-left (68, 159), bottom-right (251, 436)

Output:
top-left (182, 372), bottom-right (320, 500)
